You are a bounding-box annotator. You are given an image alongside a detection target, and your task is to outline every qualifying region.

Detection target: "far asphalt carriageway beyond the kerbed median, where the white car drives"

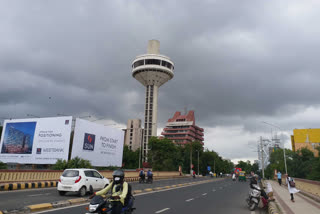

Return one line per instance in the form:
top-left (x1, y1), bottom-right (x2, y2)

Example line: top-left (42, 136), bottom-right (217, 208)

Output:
top-left (0, 177), bottom-right (218, 210)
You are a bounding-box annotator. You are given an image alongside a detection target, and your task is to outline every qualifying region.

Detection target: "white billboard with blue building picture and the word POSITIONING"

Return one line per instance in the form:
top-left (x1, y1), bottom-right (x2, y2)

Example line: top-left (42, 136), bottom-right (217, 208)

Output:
top-left (0, 117), bottom-right (72, 164)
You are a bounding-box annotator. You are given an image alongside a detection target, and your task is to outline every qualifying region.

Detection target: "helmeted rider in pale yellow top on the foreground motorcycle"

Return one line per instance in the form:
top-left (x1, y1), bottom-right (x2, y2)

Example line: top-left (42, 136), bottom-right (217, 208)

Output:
top-left (89, 169), bottom-right (128, 214)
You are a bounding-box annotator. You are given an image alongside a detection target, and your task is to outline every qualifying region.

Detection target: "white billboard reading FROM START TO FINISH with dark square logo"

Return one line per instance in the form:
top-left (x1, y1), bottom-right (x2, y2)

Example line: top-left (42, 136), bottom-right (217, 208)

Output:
top-left (71, 118), bottom-right (124, 167)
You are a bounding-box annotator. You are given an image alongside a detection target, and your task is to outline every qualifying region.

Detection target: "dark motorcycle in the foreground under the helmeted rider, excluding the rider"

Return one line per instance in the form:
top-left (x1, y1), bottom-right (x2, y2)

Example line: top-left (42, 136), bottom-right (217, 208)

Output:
top-left (86, 195), bottom-right (135, 214)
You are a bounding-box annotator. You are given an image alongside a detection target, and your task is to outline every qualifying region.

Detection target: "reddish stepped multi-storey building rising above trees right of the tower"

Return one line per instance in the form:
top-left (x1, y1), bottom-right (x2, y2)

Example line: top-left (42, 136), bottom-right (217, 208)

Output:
top-left (161, 111), bottom-right (204, 145)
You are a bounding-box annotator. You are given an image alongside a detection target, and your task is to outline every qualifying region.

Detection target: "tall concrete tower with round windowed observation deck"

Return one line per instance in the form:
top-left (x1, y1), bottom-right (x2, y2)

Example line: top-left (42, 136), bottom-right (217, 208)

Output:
top-left (132, 40), bottom-right (174, 160)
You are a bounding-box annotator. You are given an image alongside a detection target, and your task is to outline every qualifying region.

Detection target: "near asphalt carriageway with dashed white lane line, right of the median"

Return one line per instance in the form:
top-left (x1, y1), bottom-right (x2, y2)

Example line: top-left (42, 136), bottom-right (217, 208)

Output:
top-left (29, 179), bottom-right (266, 214)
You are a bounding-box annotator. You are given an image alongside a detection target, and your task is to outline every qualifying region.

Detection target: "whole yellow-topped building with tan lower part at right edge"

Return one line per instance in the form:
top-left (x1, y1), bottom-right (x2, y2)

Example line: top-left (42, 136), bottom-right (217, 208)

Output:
top-left (291, 129), bottom-right (320, 157)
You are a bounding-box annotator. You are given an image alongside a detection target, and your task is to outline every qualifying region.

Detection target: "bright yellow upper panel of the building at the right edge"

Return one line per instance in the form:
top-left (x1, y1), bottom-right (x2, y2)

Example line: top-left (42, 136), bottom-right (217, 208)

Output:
top-left (293, 129), bottom-right (320, 143)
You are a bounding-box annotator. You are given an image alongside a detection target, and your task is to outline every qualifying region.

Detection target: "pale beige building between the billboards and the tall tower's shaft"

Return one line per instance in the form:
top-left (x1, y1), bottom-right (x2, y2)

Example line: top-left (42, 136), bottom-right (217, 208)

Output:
top-left (124, 119), bottom-right (143, 151)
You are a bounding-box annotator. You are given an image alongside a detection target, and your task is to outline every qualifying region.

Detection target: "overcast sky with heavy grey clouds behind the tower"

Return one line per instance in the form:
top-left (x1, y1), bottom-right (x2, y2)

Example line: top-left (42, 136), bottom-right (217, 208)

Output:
top-left (0, 0), bottom-right (320, 161)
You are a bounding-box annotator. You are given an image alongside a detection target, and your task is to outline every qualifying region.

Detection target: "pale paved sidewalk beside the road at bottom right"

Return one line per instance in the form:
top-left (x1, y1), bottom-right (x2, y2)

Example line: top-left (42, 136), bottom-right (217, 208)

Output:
top-left (267, 180), bottom-right (320, 214)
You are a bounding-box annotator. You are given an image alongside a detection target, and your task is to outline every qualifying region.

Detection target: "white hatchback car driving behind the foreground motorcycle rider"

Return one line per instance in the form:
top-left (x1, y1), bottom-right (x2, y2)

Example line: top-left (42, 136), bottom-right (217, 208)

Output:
top-left (57, 169), bottom-right (109, 196)
